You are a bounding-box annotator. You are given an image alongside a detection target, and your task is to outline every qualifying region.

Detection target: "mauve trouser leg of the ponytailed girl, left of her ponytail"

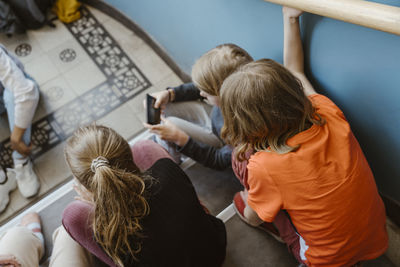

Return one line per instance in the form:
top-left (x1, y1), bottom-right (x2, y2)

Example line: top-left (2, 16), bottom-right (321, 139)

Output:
top-left (62, 200), bottom-right (117, 267)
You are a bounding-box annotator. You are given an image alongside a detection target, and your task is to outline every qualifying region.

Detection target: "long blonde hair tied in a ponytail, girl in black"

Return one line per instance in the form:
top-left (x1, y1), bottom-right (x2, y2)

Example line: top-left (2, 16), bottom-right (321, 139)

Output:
top-left (65, 125), bottom-right (149, 266)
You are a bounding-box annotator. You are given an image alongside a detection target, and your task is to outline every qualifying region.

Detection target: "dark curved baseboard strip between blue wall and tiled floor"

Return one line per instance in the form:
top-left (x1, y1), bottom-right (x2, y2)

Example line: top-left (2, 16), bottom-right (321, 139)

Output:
top-left (81, 0), bottom-right (192, 83)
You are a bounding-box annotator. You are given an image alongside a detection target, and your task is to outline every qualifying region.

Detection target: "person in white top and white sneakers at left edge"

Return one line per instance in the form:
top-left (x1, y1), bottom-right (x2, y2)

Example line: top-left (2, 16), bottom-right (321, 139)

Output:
top-left (0, 45), bottom-right (40, 215)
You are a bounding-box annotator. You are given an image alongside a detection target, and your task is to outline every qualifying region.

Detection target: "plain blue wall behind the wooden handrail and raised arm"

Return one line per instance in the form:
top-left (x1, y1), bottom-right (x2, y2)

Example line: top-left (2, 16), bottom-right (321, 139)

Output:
top-left (106, 0), bottom-right (400, 201)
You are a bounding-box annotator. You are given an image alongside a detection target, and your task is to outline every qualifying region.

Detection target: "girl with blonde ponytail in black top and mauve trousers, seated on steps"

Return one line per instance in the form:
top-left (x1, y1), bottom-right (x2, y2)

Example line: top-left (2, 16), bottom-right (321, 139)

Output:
top-left (63, 125), bottom-right (226, 266)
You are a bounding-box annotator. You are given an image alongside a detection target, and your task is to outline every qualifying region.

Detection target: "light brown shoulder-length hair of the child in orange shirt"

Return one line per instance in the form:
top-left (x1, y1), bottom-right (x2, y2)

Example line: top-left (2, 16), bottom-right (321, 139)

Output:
top-left (220, 59), bottom-right (324, 160)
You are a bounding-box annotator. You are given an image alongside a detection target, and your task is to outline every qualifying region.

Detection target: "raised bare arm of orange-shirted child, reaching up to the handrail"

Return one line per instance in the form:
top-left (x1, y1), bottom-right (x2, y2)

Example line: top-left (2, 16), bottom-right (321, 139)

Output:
top-left (282, 7), bottom-right (316, 96)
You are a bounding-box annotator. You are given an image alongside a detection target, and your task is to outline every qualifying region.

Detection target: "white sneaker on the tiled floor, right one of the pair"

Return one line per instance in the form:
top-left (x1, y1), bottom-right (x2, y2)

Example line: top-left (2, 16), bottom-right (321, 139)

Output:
top-left (7, 160), bottom-right (40, 198)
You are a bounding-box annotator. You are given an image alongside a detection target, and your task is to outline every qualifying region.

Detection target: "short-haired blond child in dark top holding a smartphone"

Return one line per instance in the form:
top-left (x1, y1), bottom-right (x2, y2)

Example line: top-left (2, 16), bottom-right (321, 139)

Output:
top-left (145, 44), bottom-right (253, 170)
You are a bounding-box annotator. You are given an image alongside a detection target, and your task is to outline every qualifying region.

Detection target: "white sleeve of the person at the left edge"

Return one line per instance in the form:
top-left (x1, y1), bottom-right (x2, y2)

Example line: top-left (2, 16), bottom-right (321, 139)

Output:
top-left (0, 49), bottom-right (39, 130)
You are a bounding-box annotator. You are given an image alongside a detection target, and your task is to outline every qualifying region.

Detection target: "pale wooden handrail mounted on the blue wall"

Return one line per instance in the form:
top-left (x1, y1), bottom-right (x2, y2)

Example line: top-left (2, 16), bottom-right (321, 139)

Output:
top-left (265, 0), bottom-right (400, 35)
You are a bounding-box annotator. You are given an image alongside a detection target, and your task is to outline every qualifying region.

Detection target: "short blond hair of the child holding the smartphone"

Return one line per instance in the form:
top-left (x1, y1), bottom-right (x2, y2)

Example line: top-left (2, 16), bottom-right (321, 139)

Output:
top-left (192, 44), bottom-right (253, 96)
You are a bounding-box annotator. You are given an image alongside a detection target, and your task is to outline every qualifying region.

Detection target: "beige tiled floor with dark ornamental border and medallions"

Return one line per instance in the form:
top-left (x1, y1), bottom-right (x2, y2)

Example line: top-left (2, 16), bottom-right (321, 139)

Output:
top-left (0, 7), bottom-right (182, 226)
